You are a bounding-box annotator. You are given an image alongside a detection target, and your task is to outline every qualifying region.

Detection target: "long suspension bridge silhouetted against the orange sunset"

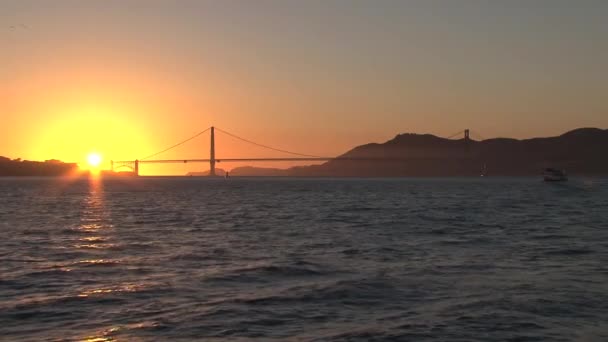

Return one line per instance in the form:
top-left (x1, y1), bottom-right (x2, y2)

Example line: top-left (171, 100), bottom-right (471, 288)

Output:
top-left (111, 126), bottom-right (478, 177)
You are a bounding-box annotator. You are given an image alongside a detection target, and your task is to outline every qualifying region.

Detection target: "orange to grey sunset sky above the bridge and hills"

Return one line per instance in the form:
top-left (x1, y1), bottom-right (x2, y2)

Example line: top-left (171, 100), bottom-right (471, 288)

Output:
top-left (0, 0), bottom-right (608, 174)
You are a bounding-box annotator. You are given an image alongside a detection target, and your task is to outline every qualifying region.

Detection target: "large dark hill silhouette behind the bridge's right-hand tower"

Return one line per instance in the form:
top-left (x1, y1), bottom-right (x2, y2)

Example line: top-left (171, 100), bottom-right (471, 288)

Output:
top-left (288, 128), bottom-right (608, 177)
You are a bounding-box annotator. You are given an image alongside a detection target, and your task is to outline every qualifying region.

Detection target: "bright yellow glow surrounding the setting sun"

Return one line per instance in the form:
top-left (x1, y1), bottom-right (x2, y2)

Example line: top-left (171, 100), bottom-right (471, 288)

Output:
top-left (23, 88), bottom-right (156, 172)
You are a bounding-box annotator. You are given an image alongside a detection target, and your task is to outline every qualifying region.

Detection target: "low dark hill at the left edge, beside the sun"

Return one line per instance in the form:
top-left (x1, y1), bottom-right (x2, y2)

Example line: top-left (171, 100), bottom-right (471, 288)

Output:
top-left (0, 156), bottom-right (78, 176)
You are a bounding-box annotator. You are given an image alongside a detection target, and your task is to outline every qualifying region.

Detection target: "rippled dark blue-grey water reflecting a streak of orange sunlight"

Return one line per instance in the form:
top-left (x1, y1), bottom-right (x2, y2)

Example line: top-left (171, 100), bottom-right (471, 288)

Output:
top-left (0, 177), bottom-right (608, 341)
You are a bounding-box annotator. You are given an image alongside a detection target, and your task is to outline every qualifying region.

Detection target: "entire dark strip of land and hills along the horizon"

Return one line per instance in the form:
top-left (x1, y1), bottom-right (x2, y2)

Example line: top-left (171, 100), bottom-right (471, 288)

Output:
top-left (0, 128), bottom-right (608, 178)
